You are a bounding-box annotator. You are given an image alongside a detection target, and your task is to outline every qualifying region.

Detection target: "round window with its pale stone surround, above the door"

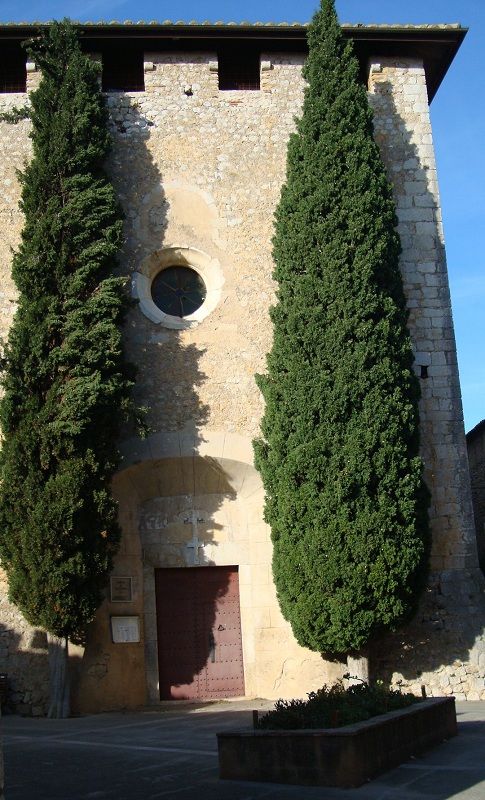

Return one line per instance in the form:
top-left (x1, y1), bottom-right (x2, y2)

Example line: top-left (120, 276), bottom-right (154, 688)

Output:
top-left (132, 246), bottom-right (224, 330)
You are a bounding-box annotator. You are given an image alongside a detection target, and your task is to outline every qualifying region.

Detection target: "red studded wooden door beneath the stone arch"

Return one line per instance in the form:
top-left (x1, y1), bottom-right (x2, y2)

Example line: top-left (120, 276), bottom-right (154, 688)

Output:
top-left (155, 567), bottom-right (244, 700)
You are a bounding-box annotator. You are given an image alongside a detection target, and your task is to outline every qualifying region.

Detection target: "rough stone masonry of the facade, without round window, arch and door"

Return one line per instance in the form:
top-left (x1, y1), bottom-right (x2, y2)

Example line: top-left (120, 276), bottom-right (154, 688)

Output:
top-left (0, 43), bottom-right (485, 708)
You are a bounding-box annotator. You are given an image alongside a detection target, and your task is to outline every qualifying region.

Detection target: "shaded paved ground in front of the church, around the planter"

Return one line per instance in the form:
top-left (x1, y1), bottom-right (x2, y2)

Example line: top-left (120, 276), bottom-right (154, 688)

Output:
top-left (2, 701), bottom-right (485, 800)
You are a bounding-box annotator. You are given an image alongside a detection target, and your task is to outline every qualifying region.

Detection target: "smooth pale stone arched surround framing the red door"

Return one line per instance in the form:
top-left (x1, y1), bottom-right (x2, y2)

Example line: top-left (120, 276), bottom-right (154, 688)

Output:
top-left (113, 431), bottom-right (334, 703)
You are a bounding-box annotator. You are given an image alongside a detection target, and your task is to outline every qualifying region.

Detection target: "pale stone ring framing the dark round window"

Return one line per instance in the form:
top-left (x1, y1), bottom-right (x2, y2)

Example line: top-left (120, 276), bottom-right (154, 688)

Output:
top-left (131, 245), bottom-right (224, 330)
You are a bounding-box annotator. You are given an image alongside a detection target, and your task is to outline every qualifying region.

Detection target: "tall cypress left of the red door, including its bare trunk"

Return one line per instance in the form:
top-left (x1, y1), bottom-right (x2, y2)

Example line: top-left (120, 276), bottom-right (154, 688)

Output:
top-left (0, 22), bottom-right (134, 716)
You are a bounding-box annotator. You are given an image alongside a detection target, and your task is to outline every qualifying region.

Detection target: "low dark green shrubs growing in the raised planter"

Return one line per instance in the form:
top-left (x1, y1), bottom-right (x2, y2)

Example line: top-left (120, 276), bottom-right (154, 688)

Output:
top-left (258, 676), bottom-right (421, 730)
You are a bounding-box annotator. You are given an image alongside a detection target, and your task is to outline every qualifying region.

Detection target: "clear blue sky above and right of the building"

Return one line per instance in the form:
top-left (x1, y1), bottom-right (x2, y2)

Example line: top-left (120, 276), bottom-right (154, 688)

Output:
top-left (0, 0), bottom-right (485, 431)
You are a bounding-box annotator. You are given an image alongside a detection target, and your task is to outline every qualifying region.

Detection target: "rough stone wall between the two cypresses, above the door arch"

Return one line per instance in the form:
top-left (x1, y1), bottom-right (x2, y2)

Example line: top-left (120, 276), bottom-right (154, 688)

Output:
top-left (108, 53), bottom-right (302, 437)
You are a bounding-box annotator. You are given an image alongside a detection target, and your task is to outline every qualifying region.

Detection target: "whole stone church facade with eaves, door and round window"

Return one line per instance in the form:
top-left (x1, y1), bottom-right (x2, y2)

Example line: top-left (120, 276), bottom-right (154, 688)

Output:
top-left (0, 23), bottom-right (485, 714)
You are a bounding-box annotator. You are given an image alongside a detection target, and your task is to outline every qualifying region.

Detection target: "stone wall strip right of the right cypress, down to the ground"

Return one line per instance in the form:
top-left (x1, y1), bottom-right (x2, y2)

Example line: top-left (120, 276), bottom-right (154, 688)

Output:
top-left (369, 59), bottom-right (485, 700)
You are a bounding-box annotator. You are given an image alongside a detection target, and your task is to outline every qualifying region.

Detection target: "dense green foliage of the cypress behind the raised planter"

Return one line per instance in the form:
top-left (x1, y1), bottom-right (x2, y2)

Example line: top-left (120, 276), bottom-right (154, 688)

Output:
top-left (255, 0), bottom-right (430, 654)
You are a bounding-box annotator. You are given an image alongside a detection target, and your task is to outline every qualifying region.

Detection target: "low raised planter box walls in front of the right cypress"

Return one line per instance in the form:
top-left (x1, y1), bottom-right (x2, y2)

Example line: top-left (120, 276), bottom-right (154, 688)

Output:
top-left (217, 697), bottom-right (457, 787)
